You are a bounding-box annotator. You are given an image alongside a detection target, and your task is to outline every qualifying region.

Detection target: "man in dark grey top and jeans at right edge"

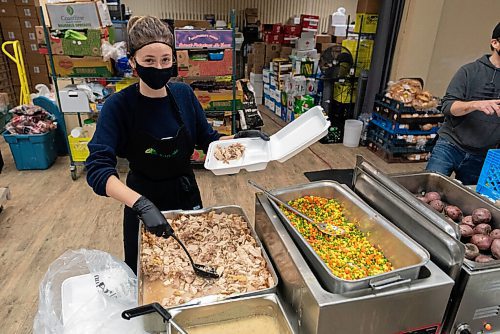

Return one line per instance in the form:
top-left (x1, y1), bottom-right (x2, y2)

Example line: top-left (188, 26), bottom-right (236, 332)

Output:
top-left (426, 23), bottom-right (500, 185)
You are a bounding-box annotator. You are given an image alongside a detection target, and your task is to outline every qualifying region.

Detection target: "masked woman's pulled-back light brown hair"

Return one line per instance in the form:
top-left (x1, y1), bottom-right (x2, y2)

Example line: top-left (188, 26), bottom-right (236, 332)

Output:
top-left (127, 15), bottom-right (174, 56)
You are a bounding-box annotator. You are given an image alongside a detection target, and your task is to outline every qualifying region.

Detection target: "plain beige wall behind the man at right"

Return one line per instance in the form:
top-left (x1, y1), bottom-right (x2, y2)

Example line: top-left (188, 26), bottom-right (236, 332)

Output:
top-left (391, 0), bottom-right (500, 96)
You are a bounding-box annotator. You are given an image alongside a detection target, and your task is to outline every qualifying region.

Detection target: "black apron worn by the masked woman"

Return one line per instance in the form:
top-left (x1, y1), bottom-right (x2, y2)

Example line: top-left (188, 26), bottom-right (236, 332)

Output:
top-left (123, 85), bottom-right (202, 272)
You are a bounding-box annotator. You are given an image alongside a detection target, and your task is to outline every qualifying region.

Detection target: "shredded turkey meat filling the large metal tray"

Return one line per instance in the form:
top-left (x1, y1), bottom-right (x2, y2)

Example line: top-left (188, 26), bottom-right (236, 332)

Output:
top-left (140, 211), bottom-right (274, 307)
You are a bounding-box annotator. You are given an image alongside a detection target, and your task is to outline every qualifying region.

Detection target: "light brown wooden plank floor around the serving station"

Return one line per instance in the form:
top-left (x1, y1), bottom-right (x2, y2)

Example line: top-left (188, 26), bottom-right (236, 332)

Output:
top-left (0, 109), bottom-right (424, 334)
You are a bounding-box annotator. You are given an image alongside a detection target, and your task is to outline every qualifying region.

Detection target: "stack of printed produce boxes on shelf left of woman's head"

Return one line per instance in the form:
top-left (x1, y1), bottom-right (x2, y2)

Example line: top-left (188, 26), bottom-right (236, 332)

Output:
top-left (42, 0), bottom-right (114, 77)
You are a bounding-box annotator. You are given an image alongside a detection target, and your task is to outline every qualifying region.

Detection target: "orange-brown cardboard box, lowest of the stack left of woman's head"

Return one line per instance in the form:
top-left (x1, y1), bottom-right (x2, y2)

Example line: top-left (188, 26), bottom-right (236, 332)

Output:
top-left (48, 55), bottom-right (113, 77)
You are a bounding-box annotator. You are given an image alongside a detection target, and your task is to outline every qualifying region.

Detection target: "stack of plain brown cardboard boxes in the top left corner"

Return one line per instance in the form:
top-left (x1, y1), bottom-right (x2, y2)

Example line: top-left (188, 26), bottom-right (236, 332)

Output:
top-left (0, 0), bottom-right (50, 101)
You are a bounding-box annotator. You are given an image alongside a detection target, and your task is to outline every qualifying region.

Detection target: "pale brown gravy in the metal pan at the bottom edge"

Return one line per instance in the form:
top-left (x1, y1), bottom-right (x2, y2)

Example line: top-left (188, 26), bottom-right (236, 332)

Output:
top-left (184, 315), bottom-right (280, 334)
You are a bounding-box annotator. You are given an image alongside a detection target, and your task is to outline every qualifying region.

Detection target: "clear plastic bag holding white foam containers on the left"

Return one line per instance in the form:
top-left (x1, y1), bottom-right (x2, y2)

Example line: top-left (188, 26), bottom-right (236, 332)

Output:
top-left (33, 249), bottom-right (146, 334)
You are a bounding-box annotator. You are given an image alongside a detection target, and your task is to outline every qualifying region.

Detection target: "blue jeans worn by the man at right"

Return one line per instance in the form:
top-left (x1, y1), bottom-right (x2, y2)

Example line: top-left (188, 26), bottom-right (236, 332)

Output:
top-left (425, 138), bottom-right (486, 185)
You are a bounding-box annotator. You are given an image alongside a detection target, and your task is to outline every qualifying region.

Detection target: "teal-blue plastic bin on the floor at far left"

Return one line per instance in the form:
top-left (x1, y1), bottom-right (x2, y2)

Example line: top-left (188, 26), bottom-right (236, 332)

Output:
top-left (3, 131), bottom-right (57, 170)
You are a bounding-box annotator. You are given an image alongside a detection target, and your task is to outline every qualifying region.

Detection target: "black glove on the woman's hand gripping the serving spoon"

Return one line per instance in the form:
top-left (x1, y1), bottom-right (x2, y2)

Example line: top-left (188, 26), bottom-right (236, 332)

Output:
top-left (132, 196), bottom-right (174, 238)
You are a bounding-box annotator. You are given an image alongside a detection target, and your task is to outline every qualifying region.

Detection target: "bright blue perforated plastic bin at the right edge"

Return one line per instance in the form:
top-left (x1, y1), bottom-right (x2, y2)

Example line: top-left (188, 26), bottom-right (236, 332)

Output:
top-left (476, 149), bottom-right (500, 200)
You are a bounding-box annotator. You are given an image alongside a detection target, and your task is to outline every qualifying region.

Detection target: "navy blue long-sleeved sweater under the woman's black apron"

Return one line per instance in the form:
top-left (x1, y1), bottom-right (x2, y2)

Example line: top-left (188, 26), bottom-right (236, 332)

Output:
top-left (85, 83), bottom-right (221, 196)
